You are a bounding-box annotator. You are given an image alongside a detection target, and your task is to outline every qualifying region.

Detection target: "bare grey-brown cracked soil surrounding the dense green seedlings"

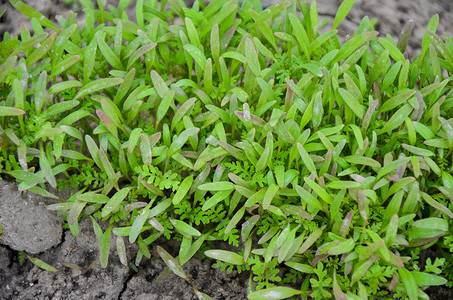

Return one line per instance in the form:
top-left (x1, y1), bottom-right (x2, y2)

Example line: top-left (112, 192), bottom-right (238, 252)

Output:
top-left (0, 0), bottom-right (453, 300)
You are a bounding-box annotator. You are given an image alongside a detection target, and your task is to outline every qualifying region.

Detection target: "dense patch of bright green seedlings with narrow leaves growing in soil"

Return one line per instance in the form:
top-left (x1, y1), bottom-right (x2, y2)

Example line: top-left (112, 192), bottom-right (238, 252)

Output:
top-left (0, 0), bottom-right (453, 299)
